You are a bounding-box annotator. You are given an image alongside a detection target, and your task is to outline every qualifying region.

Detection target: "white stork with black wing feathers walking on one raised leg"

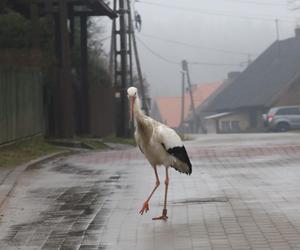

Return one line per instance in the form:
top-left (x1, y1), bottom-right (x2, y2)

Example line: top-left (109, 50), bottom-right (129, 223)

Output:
top-left (127, 87), bottom-right (192, 220)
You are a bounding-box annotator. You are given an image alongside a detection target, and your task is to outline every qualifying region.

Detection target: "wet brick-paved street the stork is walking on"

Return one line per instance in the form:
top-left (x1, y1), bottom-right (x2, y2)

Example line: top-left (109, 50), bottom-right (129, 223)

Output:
top-left (0, 134), bottom-right (300, 250)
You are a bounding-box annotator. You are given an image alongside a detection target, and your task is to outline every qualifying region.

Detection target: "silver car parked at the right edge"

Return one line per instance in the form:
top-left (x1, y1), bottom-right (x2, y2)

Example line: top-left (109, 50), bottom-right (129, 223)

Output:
top-left (263, 106), bottom-right (300, 132)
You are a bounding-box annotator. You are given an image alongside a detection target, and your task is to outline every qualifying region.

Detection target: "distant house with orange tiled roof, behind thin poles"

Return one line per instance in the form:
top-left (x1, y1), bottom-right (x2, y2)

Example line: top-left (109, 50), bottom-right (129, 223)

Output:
top-left (151, 82), bottom-right (221, 132)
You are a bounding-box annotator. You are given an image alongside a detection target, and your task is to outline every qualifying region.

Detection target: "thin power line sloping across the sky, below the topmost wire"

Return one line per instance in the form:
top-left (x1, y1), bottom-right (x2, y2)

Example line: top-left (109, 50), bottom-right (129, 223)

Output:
top-left (140, 33), bottom-right (254, 56)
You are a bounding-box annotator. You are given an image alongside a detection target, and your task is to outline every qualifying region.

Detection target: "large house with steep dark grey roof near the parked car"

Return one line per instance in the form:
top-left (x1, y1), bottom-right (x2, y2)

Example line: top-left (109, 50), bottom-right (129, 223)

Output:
top-left (197, 29), bottom-right (300, 133)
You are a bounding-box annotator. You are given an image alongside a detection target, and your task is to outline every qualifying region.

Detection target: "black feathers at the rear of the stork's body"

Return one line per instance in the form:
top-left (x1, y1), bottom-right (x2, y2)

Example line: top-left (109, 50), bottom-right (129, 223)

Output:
top-left (167, 146), bottom-right (192, 175)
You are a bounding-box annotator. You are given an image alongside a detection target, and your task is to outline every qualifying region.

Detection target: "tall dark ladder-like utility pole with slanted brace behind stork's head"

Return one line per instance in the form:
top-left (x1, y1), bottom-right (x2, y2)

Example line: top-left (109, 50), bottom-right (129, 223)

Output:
top-left (109, 0), bottom-right (149, 137)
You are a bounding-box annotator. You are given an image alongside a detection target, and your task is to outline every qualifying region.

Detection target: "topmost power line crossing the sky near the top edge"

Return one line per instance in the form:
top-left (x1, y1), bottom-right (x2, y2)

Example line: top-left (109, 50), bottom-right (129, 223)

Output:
top-left (137, 0), bottom-right (294, 23)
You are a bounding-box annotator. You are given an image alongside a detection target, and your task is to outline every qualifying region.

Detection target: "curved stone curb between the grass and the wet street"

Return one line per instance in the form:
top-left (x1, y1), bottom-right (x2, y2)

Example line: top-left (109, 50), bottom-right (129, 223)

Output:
top-left (0, 150), bottom-right (71, 210)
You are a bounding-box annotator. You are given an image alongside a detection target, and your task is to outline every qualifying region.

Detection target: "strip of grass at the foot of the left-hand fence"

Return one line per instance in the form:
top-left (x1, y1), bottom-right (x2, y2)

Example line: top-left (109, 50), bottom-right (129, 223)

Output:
top-left (0, 136), bottom-right (62, 167)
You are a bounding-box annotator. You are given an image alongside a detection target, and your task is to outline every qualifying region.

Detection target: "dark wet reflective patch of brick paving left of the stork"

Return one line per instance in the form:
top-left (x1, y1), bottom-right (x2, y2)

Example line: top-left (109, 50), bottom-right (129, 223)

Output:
top-left (0, 153), bottom-right (130, 249)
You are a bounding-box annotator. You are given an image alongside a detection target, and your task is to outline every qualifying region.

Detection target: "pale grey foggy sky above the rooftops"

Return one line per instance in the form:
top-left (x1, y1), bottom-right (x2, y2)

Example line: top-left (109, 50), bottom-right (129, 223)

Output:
top-left (101, 0), bottom-right (299, 97)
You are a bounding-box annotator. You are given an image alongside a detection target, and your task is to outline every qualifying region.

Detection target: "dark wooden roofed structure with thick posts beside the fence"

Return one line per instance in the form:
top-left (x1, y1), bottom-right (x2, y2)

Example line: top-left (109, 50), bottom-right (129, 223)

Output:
top-left (9, 0), bottom-right (117, 137)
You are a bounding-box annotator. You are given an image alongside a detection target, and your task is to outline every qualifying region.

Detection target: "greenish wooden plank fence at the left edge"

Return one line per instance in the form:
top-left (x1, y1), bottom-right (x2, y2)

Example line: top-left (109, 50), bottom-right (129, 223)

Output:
top-left (0, 68), bottom-right (44, 144)
